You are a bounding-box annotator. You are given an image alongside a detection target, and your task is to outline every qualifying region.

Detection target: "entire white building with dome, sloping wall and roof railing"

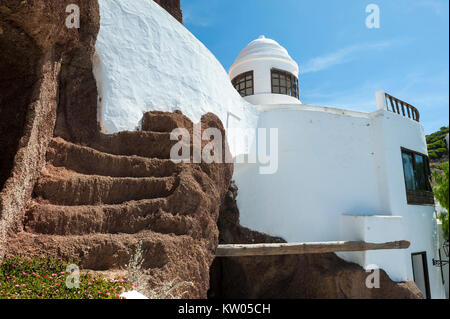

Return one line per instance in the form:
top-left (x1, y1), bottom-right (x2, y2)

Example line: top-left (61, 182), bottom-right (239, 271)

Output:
top-left (94, 0), bottom-right (445, 298)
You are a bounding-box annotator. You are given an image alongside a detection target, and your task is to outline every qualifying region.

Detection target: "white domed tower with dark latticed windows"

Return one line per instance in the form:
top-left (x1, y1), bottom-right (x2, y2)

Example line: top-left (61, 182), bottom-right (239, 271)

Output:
top-left (229, 36), bottom-right (301, 105)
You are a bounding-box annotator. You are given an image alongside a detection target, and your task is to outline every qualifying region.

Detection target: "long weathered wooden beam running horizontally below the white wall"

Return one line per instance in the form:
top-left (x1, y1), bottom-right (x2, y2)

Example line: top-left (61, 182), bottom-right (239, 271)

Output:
top-left (216, 240), bottom-right (410, 257)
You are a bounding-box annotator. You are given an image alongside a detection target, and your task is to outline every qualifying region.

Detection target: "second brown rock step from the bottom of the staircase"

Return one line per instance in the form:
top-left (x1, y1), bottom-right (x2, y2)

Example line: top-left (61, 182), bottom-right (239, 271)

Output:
top-left (24, 198), bottom-right (195, 235)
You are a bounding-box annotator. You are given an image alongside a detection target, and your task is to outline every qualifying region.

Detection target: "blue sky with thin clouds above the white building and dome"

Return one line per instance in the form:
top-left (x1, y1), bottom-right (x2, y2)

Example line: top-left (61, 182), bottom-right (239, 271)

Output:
top-left (181, 0), bottom-right (449, 133)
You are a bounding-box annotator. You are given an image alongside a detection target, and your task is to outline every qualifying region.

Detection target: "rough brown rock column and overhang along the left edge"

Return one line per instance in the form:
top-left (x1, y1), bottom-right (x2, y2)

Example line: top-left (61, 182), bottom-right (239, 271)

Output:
top-left (0, 0), bottom-right (99, 259)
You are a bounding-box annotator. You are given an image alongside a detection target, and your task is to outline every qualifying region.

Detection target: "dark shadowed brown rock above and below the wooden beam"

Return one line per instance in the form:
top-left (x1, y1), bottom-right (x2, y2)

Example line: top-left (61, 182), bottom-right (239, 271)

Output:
top-left (209, 185), bottom-right (423, 299)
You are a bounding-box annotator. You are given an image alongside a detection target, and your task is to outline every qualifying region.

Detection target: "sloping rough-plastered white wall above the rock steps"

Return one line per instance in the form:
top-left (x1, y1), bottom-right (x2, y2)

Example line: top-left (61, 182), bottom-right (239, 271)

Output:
top-left (94, 0), bottom-right (258, 154)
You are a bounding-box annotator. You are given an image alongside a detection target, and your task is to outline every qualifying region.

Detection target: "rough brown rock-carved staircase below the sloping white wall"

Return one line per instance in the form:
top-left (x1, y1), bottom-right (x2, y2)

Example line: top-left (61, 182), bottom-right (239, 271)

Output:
top-left (7, 112), bottom-right (233, 298)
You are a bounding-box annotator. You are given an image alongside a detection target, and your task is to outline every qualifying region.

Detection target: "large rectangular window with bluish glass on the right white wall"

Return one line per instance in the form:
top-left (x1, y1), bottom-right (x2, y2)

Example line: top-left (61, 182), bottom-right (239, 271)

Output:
top-left (402, 148), bottom-right (434, 205)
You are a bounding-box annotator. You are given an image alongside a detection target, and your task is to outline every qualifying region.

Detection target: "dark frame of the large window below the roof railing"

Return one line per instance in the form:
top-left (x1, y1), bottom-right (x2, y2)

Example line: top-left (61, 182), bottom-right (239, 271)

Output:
top-left (401, 147), bottom-right (435, 206)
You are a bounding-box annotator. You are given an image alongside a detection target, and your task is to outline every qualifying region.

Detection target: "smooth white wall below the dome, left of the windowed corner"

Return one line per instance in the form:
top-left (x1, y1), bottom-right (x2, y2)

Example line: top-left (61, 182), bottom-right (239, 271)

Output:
top-left (235, 105), bottom-right (383, 242)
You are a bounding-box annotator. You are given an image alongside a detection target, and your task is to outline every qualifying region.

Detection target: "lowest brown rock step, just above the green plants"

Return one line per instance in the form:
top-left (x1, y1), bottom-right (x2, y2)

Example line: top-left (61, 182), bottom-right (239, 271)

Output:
top-left (6, 231), bottom-right (194, 271)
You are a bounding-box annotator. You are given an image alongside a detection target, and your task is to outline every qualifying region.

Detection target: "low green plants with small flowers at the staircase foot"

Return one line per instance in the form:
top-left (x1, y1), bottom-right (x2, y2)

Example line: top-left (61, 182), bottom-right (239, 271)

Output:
top-left (0, 257), bottom-right (132, 299)
